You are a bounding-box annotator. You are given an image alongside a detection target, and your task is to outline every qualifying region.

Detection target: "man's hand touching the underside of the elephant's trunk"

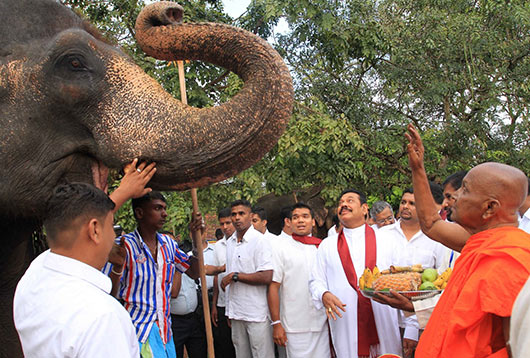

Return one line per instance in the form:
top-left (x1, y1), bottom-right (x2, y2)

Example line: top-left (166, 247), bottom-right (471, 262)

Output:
top-left (109, 158), bottom-right (156, 212)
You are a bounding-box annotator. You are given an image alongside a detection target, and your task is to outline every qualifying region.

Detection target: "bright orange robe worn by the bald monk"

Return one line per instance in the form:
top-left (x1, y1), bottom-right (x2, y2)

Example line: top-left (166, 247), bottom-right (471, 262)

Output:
top-left (416, 227), bottom-right (530, 358)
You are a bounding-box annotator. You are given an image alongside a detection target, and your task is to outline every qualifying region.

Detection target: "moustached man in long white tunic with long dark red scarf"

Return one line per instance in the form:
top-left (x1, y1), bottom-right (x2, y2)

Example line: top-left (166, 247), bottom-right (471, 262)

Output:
top-left (309, 189), bottom-right (401, 358)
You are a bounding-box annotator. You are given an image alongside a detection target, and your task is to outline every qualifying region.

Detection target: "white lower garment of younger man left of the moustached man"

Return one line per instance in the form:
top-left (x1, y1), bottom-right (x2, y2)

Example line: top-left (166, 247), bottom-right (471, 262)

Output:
top-left (286, 325), bottom-right (331, 358)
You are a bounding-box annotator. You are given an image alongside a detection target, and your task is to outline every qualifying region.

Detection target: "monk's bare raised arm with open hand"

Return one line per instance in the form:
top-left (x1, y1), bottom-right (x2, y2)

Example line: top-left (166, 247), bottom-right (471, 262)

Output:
top-left (405, 124), bottom-right (471, 251)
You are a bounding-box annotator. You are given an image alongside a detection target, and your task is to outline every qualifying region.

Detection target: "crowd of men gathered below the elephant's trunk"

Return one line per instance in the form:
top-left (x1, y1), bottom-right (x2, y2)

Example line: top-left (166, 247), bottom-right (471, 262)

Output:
top-left (10, 126), bottom-right (530, 358)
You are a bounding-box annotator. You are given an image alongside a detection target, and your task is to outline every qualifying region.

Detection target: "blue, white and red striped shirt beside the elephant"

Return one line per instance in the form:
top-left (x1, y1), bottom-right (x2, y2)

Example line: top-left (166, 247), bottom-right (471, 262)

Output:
top-left (104, 230), bottom-right (189, 344)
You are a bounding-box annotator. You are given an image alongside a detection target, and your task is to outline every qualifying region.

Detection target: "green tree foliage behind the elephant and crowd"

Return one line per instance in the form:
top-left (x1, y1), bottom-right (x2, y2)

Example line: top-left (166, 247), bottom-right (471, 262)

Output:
top-left (63, 0), bottom-right (530, 231)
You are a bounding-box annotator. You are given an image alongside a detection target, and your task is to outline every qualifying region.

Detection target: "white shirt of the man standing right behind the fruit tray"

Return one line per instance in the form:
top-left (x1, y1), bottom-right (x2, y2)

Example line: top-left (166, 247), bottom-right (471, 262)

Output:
top-left (377, 221), bottom-right (447, 270)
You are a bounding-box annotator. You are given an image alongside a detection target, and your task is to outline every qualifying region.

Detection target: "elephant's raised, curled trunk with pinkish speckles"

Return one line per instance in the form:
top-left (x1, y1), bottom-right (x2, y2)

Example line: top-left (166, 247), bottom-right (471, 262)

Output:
top-left (98, 2), bottom-right (293, 190)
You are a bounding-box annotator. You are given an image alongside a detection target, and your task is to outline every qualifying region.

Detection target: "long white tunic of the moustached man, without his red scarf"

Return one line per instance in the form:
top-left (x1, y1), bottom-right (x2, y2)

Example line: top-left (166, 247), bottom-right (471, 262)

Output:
top-left (309, 225), bottom-right (401, 358)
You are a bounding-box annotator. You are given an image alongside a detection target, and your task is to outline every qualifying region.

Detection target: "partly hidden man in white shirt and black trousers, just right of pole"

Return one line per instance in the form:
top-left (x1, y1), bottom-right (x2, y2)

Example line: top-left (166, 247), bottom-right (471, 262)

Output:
top-left (212, 208), bottom-right (236, 358)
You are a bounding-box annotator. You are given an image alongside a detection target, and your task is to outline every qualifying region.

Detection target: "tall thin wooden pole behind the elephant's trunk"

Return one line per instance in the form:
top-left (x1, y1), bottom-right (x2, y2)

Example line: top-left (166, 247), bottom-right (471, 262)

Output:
top-left (177, 61), bottom-right (215, 358)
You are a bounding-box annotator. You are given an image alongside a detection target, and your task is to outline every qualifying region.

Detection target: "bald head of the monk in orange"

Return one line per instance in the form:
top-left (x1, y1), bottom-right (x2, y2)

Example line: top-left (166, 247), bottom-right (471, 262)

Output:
top-left (452, 163), bottom-right (528, 232)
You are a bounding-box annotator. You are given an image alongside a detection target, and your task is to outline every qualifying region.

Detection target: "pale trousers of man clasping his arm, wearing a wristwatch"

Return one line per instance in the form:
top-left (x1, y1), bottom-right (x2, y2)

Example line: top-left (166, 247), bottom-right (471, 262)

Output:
top-left (230, 319), bottom-right (274, 358)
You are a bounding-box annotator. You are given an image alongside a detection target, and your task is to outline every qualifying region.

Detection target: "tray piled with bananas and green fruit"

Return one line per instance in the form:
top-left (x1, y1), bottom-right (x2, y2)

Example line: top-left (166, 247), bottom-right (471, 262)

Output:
top-left (359, 265), bottom-right (452, 300)
